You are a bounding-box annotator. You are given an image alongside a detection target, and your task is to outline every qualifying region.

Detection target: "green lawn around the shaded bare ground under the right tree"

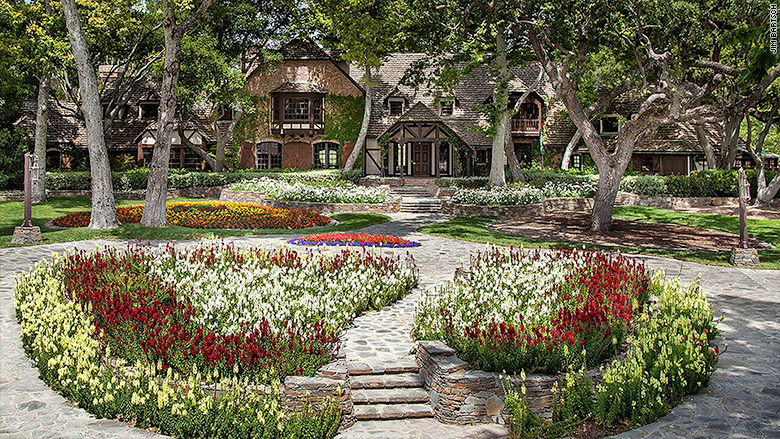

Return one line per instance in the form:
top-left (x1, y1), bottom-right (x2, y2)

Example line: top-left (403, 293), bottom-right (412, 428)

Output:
top-left (420, 207), bottom-right (780, 270)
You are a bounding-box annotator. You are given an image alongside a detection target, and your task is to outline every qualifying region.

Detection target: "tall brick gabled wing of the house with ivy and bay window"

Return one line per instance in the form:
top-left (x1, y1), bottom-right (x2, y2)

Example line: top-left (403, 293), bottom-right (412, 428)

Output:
top-left (240, 40), bottom-right (365, 169)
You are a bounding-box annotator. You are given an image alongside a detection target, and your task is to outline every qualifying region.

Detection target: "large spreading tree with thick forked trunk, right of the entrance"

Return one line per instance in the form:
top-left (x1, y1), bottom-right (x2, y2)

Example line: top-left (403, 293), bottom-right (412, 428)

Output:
top-left (516, 0), bottom-right (776, 232)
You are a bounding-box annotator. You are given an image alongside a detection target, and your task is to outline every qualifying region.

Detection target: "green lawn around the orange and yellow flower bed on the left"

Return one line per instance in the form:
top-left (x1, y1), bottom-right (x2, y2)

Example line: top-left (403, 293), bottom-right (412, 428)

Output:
top-left (0, 197), bottom-right (390, 248)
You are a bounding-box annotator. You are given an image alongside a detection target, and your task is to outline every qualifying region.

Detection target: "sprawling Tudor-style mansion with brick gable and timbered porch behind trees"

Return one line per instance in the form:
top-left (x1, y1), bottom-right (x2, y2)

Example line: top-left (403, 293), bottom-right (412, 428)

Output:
top-left (17, 40), bottom-right (777, 178)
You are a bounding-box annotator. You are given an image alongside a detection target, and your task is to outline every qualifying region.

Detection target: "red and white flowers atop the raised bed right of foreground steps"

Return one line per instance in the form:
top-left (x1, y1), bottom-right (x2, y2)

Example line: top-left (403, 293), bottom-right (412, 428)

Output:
top-left (414, 248), bottom-right (649, 373)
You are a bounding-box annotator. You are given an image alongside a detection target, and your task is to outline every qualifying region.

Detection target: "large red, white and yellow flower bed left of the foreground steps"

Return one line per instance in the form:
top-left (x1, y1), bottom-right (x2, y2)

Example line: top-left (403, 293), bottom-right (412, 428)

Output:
top-left (14, 244), bottom-right (417, 438)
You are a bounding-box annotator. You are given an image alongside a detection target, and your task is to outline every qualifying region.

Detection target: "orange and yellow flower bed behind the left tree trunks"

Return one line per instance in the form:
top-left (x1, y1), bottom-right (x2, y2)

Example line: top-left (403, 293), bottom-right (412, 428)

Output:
top-left (52, 201), bottom-right (330, 229)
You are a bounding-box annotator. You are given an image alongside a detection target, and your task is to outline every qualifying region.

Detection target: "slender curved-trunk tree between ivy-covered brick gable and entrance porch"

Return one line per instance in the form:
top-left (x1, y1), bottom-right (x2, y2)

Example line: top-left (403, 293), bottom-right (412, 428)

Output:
top-left (318, 0), bottom-right (413, 172)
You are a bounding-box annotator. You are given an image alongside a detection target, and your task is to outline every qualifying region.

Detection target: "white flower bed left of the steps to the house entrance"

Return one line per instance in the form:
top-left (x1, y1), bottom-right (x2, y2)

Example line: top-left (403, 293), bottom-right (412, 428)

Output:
top-left (229, 178), bottom-right (386, 204)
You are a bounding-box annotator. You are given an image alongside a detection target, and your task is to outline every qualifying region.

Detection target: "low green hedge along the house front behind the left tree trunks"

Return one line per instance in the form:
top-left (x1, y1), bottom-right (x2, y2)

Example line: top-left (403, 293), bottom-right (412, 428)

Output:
top-left (46, 168), bottom-right (340, 191)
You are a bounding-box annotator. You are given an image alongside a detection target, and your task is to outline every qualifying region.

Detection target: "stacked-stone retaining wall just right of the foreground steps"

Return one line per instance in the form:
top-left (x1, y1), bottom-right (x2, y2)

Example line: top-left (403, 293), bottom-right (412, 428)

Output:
top-left (417, 341), bottom-right (600, 424)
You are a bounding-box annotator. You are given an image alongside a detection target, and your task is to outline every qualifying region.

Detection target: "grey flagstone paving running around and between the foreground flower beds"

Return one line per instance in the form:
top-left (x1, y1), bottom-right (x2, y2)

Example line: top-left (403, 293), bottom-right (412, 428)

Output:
top-left (0, 214), bottom-right (780, 439)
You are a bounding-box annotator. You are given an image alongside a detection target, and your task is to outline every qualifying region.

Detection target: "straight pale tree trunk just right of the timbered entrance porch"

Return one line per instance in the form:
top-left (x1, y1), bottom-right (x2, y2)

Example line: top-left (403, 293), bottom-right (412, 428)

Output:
top-left (489, 29), bottom-right (512, 187)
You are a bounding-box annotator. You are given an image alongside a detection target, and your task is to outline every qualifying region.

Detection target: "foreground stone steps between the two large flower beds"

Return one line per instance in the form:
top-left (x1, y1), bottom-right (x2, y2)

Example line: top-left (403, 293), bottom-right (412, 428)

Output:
top-left (349, 360), bottom-right (433, 421)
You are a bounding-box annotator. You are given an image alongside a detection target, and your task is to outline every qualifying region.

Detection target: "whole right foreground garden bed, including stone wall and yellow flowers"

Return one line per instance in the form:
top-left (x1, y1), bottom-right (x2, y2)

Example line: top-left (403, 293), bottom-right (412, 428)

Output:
top-left (414, 248), bottom-right (719, 437)
